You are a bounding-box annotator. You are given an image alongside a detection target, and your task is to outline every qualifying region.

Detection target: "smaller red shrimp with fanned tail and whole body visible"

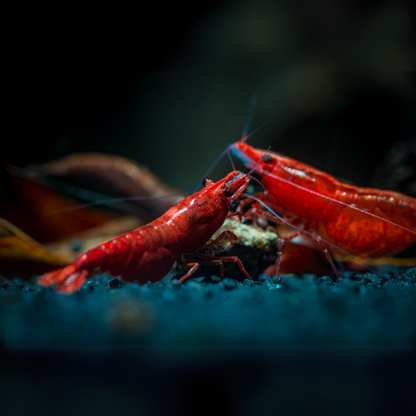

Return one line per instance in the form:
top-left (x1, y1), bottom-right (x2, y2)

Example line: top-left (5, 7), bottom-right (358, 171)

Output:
top-left (38, 171), bottom-right (252, 294)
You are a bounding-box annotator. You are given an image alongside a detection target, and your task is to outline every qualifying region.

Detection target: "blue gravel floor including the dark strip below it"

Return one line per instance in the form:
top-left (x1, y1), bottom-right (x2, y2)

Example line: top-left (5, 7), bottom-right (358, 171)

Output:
top-left (0, 269), bottom-right (416, 416)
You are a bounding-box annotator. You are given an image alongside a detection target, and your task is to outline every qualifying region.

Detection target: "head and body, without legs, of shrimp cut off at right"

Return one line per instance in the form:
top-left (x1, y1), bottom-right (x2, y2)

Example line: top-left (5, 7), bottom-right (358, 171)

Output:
top-left (232, 143), bottom-right (416, 258)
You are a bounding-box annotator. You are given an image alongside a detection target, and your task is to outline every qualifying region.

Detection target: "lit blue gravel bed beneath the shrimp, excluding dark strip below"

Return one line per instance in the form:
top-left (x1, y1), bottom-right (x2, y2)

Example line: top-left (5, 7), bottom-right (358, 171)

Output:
top-left (0, 269), bottom-right (416, 347)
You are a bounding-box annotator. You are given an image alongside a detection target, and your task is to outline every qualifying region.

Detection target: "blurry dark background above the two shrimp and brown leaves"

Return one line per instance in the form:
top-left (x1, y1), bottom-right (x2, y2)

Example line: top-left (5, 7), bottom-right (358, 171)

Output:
top-left (1, 1), bottom-right (416, 190)
